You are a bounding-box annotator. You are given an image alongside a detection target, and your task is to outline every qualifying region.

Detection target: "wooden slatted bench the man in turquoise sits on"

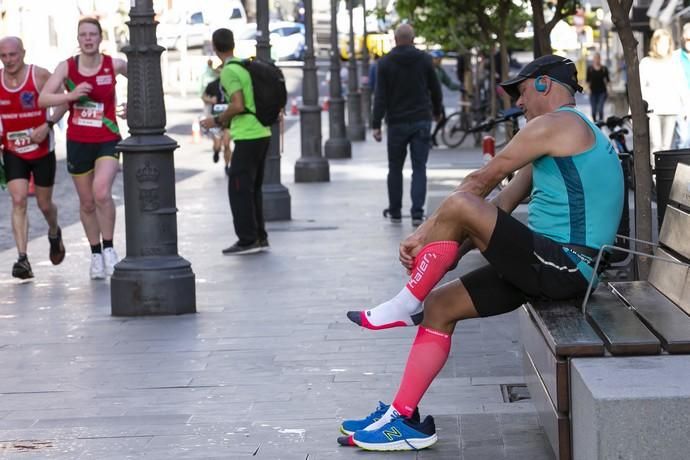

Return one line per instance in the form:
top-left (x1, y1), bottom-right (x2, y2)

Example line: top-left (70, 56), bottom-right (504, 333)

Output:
top-left (520, 164), bottom-right (690, 460)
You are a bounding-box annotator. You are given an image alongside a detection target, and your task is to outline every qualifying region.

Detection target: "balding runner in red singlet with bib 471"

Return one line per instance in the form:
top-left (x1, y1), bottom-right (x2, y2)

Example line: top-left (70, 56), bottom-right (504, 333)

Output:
top-left (0, 37), bottom-right (67, 279)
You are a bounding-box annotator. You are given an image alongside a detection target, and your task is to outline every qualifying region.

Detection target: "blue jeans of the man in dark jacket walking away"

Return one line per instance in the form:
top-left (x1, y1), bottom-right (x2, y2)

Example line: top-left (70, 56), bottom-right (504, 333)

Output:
top-left (388, 120), bottom-right (431, 218)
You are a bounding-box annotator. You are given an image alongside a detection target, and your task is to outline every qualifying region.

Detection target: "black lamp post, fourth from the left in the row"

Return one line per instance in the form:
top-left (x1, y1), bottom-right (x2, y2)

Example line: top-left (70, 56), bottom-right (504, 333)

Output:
top-left (324, 0), bottom-right (352, 158)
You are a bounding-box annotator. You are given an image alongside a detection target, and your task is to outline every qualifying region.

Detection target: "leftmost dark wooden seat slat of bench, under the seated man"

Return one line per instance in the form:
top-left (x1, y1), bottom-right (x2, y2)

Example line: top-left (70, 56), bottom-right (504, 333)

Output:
top-left (528, 301), bottom-right (604, 357)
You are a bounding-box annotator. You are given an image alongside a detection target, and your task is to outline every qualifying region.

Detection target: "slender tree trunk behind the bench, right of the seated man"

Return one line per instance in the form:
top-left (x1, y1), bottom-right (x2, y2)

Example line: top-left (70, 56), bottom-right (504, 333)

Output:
top-left (608, 0), bottom-right (652, 279)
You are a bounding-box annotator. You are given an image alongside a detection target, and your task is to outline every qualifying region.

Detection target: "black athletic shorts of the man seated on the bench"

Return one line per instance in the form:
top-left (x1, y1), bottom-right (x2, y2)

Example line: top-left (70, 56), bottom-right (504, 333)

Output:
top-left (460, 210), bottom-right (589, 316)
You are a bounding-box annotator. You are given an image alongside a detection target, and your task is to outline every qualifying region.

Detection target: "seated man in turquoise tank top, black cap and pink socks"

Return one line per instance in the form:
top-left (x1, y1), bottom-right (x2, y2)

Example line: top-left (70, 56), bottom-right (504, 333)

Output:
top-left (338, 55), bottom-right (623, 450)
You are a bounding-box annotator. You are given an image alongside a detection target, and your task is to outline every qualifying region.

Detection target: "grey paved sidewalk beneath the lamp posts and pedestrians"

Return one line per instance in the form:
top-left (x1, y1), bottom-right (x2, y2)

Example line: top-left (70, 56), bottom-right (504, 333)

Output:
top-left (0, 101), bottom-right (553, 460)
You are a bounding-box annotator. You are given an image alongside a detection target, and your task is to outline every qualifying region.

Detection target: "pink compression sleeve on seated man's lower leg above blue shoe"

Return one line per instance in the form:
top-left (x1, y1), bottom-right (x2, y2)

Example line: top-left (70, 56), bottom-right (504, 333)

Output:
top-left (393, 326), bottom-right (451, 417)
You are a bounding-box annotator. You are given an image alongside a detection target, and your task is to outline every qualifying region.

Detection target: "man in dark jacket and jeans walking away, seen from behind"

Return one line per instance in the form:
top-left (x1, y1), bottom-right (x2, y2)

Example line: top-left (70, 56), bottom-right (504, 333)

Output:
top-left (371, 24), bottom-right (442, 226)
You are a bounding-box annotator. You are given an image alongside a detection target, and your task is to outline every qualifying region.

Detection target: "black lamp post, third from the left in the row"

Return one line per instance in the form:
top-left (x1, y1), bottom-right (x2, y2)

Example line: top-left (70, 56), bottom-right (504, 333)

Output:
top-left (295, 0), bottom-right (330, 182)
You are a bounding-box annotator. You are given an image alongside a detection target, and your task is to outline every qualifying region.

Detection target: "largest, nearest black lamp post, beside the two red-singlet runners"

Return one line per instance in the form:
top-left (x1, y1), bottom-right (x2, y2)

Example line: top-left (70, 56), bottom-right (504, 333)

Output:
top-left (110, 0), bottom-right (196, 316)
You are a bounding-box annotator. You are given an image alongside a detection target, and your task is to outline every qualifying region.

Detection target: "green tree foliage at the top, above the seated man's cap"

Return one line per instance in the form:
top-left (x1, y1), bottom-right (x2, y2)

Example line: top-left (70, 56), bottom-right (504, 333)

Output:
top-left (396, 0), bottom-right (530, 51)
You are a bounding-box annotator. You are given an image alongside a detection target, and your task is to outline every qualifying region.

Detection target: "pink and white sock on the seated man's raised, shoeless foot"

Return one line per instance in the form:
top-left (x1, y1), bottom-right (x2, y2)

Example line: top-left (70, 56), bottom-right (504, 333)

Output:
top-left (347, 241), bottom-right (459, 330)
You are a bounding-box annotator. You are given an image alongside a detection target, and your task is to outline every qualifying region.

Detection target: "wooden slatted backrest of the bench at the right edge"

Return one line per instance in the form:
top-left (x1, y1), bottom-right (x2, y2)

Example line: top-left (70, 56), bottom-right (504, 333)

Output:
top-left (648, 163), bottom-right (690, 314)
